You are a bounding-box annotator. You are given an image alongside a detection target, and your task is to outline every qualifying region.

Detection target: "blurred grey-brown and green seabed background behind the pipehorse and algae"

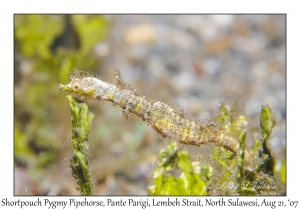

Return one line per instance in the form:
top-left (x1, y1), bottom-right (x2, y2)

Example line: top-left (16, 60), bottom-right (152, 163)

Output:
top-left (14, 15), bottom-right (286, 195)
